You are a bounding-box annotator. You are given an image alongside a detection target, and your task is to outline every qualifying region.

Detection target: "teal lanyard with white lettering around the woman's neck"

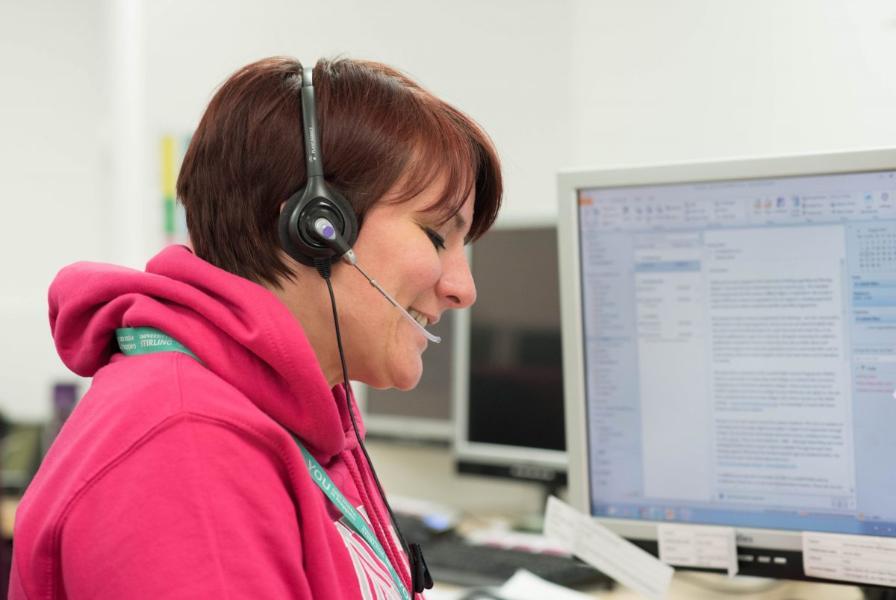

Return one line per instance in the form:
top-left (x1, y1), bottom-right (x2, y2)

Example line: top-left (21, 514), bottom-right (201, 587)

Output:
top-left (115, 327), bottom-right (410, 600)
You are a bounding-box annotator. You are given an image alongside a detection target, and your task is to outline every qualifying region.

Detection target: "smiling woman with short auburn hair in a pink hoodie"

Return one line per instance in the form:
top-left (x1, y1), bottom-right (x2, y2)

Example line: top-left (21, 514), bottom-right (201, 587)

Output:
top-left (10, 58), bottom-right (502, 599)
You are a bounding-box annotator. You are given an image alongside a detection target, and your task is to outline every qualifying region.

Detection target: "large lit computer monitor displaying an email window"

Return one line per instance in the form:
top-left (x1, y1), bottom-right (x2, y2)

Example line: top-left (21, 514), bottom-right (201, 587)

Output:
top-left (559, 150), bottom-right (896, 579)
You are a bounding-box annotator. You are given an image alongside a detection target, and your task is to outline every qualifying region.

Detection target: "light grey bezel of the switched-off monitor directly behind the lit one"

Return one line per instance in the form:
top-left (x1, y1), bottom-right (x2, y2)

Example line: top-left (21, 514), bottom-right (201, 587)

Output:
top-left (452, 215), bottom-right (568, 484)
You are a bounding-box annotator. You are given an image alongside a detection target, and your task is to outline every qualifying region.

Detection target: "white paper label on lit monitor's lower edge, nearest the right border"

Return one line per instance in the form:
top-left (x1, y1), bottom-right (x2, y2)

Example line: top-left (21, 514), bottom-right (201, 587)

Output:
top-left (803, 531), bottom-right (896, 587)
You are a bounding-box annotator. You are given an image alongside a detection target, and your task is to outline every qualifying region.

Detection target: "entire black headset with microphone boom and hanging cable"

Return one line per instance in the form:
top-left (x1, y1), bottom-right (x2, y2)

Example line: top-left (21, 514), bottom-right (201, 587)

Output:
top-left (278, 62), bottom-right (440, 593)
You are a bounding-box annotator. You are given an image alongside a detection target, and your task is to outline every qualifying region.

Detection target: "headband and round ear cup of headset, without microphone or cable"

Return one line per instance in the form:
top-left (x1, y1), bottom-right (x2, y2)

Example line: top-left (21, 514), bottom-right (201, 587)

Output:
top-left (278, 68), bottom-right (358, 266)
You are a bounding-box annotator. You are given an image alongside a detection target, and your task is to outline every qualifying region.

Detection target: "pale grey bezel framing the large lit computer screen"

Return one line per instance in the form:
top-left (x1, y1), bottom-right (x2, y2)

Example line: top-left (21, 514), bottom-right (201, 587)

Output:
top-left (557, 148), bottom-right (896, 560)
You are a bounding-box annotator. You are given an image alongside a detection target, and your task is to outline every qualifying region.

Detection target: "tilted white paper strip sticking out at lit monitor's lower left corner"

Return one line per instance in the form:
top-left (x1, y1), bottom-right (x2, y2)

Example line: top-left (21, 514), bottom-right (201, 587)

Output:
top-left (544, 496), bottom-right (674, 598)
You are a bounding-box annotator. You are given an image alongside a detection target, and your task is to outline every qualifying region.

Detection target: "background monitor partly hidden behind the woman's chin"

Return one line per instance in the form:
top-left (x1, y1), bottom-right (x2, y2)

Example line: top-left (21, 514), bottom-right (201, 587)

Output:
top-left (358, 311), bottom-right (454, 444)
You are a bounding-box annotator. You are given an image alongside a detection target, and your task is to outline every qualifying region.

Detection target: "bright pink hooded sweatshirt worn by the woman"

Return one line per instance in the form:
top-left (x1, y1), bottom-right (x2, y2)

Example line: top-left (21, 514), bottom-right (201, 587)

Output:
top-left (9, 246), bottom-right (420, 600)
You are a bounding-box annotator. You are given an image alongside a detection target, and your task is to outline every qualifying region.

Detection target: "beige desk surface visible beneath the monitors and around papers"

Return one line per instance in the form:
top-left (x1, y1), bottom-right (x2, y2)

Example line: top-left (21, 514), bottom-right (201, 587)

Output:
top-left (367, 440), bottom-right (862, 600)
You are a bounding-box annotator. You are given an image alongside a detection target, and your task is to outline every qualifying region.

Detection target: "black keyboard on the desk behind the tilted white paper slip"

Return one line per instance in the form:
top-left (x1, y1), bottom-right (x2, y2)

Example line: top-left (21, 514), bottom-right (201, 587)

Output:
top-left (423, 536), bottom-right (613, 589)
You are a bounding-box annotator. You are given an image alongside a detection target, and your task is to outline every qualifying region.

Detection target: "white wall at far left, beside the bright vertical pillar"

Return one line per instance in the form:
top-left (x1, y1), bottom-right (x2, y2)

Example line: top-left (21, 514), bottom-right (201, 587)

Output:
top-left (0, 0), bottom-right (110, 418)
